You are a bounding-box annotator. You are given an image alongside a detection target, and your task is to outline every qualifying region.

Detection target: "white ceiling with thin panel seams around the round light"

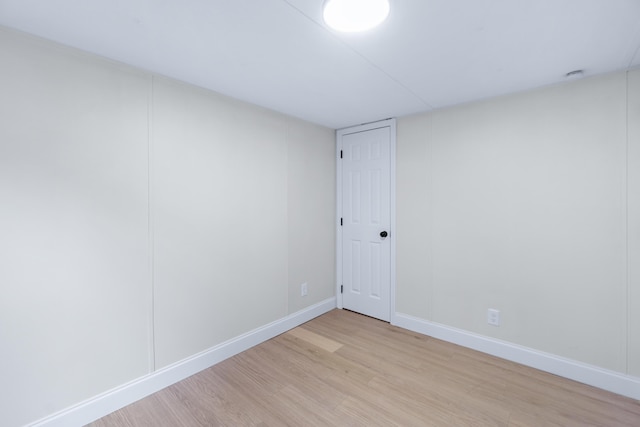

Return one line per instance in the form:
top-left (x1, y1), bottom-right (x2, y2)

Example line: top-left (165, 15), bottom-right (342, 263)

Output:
top-left (0, 0), bottom-right (640, 129)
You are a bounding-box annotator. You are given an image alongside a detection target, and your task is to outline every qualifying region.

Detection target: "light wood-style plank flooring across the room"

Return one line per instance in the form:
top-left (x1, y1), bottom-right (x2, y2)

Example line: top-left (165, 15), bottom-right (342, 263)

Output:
top-left (91, 310), bottom-right (640, 427)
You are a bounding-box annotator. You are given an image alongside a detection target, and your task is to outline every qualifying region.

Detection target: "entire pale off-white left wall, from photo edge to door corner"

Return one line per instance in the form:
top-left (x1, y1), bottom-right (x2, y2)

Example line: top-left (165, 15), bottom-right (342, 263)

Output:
top-left (0, 29), bottom-right (335, 426)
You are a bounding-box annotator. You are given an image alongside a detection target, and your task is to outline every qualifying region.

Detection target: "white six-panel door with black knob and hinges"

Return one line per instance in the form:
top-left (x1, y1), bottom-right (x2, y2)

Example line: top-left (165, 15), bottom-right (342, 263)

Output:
top-left (338, 124), bottom-right (395, 321)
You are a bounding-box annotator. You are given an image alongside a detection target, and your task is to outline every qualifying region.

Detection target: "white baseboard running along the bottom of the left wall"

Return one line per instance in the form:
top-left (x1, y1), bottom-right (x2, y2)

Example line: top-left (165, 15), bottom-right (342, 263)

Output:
top-left (30, 297), bottom-right (336, 427)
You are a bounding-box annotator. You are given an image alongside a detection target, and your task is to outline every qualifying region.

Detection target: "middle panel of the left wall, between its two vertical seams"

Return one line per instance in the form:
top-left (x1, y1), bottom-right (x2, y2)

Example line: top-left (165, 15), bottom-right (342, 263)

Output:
top-left (152, 79), bottom-right (287, 367)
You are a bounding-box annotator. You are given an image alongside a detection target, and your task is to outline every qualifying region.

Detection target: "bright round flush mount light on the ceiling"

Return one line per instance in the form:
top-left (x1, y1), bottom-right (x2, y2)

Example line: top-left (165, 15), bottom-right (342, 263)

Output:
top-left (323, 0), bottom-right (389, 33)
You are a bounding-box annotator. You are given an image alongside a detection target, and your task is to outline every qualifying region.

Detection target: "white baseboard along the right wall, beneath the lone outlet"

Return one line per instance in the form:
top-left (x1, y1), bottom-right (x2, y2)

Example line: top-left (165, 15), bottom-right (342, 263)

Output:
top-left (393, 313), bottom-right (640, 400)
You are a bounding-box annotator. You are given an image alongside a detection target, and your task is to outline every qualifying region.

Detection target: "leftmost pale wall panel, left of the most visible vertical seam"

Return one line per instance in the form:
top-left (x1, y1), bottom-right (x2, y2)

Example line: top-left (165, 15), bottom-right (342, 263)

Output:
top-left (0, 27), bottom-right (150, 426)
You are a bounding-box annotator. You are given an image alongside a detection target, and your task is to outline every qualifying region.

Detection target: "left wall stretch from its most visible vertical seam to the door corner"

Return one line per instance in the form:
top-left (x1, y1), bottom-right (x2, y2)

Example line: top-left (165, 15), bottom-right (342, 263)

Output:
top-left (152, 78), bottom-right (335, 368)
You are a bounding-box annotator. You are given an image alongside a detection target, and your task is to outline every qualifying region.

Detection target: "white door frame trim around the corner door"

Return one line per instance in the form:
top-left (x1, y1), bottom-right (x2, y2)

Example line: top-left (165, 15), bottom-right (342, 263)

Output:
top-left (336, 118), bottom-right (396, 325)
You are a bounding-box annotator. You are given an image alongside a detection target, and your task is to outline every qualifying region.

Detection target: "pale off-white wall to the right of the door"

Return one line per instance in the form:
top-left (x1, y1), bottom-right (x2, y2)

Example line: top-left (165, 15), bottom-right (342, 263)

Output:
top-left (397, 70), bottom-right (640, 376)
